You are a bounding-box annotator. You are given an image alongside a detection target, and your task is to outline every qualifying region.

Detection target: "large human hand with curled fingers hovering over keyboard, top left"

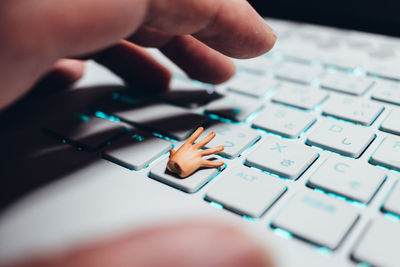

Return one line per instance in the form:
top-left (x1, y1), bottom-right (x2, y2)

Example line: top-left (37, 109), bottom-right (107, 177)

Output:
top-left (0, 0), bottom-right (276, 110)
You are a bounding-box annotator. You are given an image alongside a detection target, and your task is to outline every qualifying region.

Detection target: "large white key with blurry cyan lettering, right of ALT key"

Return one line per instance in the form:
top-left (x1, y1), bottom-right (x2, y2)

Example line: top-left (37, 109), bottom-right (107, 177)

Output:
top-left (272, 190), bottom-right (358, 250)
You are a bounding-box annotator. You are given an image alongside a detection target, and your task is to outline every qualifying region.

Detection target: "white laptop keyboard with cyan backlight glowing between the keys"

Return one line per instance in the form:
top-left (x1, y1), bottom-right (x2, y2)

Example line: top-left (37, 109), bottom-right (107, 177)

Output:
top-left (41, 20), bottom-right (400, 266)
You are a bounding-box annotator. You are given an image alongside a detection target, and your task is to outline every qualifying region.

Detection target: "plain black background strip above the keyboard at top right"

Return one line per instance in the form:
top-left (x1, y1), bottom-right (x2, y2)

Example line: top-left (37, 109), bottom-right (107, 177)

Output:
top-left (249, 0), bottom-right (400, 36)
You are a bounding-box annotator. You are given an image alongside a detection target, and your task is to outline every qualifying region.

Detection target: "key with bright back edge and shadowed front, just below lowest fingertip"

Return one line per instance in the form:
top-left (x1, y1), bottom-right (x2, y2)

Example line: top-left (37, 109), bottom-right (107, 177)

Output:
top-left (160, 79), bottom-right (222, 108)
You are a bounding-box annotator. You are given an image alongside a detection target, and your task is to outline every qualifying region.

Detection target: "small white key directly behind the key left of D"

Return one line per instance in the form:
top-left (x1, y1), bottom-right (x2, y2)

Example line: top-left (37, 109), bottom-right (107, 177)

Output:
top-left (272, 83), bottom-right (328, 110)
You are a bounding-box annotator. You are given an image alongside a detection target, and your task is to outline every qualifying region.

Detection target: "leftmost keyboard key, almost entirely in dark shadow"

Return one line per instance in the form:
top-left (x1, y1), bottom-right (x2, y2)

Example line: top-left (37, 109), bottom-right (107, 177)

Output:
top-left (45, 114), bottom-right (127, 151)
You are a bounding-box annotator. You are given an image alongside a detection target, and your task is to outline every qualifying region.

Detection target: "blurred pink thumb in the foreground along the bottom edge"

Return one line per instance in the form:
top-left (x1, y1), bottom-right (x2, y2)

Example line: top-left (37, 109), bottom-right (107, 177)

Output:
top-left (9, 222), bottom-right (273, 267)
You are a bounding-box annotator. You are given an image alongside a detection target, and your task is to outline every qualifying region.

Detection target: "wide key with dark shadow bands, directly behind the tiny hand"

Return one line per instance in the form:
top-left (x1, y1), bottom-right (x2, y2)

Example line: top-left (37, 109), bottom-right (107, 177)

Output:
top-left (104, 101), bottom-right (208, 140)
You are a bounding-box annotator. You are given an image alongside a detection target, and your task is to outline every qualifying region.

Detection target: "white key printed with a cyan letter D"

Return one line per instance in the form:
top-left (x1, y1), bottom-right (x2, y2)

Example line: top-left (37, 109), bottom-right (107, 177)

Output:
top-left (306, 119), bottom-right (375, 158)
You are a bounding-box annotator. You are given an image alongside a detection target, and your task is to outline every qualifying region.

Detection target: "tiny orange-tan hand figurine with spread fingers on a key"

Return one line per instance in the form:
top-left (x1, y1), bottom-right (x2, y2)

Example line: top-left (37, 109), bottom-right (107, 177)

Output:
top-left (167, 127), bottom-right (224, 178)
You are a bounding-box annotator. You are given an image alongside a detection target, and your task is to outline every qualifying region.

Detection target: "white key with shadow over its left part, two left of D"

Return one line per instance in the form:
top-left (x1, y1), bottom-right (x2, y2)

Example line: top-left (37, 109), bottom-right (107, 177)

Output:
top-left (205, 94), bottom-right (264, 121)
